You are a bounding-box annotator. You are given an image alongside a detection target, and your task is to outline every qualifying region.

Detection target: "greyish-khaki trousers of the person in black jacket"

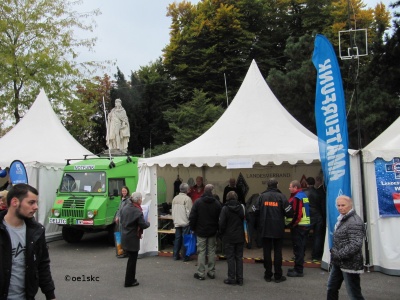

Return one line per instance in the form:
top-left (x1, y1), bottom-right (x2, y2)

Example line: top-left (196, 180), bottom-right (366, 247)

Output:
top-left (197, 235), bottom-right (217, 277)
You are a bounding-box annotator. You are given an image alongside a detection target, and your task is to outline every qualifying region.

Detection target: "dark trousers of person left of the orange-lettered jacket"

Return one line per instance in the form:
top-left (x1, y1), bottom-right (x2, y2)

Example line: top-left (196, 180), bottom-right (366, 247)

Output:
top-left (225, 243), bottom-right (244, 281)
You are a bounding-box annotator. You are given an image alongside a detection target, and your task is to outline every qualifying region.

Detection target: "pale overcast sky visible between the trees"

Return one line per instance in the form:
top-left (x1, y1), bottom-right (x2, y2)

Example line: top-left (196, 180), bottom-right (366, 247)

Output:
top-left (76, 0), bottom-right (392, 79)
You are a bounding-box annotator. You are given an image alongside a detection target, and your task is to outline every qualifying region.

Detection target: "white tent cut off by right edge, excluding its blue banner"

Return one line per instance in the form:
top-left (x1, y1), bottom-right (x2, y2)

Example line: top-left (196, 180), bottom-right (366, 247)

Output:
top-left (363, 117), bottom-right (400, 276)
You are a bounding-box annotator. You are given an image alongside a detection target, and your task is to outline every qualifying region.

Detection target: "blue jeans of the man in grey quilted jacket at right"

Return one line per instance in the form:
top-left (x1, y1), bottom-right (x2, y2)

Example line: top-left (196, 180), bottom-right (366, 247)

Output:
top-left (326, 265), bottom-right (364, 300)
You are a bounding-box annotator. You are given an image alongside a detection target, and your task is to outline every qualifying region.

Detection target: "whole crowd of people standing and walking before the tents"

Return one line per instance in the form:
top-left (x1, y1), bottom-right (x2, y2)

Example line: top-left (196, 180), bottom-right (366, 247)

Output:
top-left (0, 176), bottom-right (365, 299)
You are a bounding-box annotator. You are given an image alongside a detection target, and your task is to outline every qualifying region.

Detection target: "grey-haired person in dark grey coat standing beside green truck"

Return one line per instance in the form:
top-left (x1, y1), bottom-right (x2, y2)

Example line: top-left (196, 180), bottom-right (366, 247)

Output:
top-left (120, 192), bottom-right (150, 287)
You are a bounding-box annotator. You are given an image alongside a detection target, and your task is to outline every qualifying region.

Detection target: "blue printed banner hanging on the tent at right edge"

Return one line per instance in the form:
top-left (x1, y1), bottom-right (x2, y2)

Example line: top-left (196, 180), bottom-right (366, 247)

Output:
top-left (375, 157), bottom-right (400, 217)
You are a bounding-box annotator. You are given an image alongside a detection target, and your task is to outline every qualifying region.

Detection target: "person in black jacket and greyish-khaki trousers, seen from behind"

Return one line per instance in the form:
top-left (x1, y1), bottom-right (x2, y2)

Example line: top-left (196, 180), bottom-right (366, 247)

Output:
top-left (189, 184), bottom-right (221, 280)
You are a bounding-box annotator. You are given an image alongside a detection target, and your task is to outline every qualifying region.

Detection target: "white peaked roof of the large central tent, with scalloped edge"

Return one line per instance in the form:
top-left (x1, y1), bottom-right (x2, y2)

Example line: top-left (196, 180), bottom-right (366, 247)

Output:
top-left (139, 60), bottom-right (319, 167)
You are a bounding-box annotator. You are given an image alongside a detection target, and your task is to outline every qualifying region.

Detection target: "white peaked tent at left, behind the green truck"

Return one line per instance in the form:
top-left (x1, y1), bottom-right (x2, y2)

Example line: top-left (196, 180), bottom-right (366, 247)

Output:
top-left (0, 89), bottom-right (93, 238)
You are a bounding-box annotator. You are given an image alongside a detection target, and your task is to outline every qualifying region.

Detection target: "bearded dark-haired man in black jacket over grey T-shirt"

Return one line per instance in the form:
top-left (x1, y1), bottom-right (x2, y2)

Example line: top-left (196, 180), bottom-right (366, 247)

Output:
top-left (0, 183), bottom-right (56, 300)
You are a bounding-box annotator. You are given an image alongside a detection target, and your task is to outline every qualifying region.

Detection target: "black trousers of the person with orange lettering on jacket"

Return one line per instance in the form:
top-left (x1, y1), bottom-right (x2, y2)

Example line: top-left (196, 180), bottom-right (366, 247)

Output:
top-left (263, 238), bottom-right (282, 279)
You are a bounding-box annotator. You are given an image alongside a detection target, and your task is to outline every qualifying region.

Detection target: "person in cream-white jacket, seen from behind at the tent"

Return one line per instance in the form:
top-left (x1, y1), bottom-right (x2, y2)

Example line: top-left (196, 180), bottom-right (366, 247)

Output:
top-left (172, 183), bottom-right (192, 261)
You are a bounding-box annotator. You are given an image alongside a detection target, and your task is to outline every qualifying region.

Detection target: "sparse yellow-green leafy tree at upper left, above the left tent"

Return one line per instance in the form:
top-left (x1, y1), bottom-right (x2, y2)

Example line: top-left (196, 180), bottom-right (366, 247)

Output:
top-left (0, 0), bottom-right (99, 123)
